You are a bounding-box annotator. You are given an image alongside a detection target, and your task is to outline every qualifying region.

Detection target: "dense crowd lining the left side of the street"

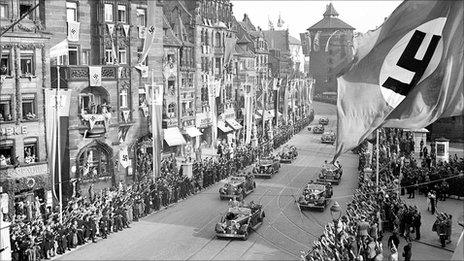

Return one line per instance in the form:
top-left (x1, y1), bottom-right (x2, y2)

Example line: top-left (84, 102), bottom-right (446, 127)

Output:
top-left (7, 115), bottom-right (316, 261)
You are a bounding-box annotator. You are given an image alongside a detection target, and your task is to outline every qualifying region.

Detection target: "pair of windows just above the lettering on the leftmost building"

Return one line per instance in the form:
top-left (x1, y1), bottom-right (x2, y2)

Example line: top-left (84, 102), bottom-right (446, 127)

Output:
top-left (0, 94), bottom-right (38, 122)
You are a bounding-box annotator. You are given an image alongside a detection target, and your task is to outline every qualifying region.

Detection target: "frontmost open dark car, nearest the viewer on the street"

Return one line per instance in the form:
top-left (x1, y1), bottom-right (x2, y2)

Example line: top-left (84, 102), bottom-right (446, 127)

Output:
top-left (215, 201), bottom-right (265, 240)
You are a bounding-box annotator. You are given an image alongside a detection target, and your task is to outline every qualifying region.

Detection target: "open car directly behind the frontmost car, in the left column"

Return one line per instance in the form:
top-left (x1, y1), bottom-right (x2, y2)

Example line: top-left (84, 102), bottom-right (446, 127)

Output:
top-left (219, 174), bottom-right (256, 201)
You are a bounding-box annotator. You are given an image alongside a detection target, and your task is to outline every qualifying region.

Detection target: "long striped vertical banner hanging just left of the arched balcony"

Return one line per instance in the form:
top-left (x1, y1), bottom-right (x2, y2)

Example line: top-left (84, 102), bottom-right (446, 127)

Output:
top-left (44, 89), bottom-right (72, 198)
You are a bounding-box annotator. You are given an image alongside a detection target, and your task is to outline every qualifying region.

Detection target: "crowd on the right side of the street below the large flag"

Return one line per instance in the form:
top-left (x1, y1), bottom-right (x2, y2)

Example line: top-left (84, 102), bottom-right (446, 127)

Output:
top-left (302, 126), bottom-right (464, 260)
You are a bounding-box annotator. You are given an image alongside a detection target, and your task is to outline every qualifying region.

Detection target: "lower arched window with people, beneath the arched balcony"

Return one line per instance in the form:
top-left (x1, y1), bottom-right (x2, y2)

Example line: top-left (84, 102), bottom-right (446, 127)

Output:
top-left (77, 142), bottom-right (112, 180)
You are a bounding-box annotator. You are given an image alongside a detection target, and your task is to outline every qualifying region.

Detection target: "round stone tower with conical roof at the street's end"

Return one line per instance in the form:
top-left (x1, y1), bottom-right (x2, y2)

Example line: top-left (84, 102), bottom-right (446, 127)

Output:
top-left (308, 3), bottom-right (355, 94)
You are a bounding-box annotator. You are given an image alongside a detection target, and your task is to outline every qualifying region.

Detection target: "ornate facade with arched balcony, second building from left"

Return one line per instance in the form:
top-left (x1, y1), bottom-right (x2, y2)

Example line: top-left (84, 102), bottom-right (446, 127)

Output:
top-left (44, 0), bottom-right (164, 196)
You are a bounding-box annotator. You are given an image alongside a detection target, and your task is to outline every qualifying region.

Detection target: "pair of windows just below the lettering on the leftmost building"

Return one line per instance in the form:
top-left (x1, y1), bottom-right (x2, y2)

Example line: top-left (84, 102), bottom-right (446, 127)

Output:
top-left (0, 137), bottom-right (39, 168)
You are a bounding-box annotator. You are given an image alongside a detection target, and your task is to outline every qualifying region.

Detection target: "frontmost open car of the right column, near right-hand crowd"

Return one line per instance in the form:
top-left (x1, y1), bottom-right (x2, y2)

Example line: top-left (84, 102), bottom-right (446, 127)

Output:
top-left (298, 180), bottom-right (333, 211)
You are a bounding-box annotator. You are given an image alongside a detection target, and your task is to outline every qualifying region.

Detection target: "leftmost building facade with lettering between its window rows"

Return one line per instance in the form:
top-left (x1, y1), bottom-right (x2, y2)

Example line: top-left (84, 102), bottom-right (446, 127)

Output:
top-left (0, 0), bottom-right (52, 214)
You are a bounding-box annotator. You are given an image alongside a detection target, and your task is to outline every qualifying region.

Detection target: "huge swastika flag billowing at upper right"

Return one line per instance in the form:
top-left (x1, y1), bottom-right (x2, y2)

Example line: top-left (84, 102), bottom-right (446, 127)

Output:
top-left (335, 1), bottom-right (464, 157)
